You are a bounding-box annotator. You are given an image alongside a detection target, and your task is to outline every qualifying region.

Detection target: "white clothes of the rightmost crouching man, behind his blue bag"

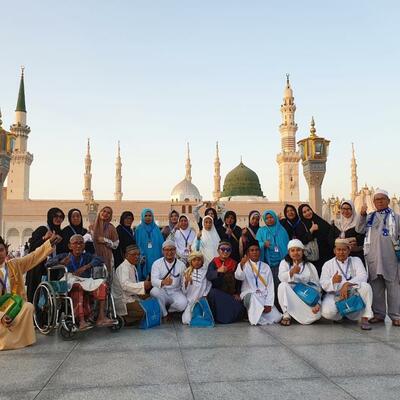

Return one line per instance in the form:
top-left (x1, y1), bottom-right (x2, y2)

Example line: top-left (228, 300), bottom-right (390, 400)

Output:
top-left (320, 257), bottom-right (373, 321)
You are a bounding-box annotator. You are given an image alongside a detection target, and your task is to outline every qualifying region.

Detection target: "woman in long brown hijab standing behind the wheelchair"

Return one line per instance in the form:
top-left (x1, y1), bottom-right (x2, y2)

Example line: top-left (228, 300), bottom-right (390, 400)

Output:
top-left (92, 206), bottom-right (119, 273)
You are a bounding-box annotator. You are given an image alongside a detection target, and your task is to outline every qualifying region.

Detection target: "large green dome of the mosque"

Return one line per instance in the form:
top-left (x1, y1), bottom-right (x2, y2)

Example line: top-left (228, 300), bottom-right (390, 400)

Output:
top-left (221, 162), bottom-right (263, 197)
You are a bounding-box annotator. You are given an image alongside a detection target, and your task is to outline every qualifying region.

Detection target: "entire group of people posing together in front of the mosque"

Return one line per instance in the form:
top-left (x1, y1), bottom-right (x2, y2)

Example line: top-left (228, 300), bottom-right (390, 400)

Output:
top-left (0, 190), bottom-right (400, 350)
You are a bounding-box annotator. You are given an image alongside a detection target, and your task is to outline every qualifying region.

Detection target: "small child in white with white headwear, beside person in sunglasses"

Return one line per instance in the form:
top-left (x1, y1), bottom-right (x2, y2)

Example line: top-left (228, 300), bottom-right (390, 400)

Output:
top-left (182, 251), bottom-right (211, 324)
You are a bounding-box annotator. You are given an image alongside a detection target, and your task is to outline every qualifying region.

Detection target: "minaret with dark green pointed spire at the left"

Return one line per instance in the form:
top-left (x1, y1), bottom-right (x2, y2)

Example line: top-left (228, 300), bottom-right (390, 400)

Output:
top-left (7, 67), bottom-right (33, 200)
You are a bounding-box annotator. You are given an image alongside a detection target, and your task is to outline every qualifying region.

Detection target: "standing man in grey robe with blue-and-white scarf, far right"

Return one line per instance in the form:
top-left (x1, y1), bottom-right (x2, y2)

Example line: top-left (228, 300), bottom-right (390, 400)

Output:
top-left (356, 190), bottom-right (400, 326)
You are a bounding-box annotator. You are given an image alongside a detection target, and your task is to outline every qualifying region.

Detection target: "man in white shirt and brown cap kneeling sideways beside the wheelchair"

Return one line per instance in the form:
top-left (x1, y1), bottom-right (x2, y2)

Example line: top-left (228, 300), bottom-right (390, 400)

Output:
top-left (116, 245), bottom-right (151, 324)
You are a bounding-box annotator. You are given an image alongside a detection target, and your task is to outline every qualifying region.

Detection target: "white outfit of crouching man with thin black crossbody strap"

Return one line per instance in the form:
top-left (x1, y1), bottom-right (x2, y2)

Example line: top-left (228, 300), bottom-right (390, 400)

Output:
top-left (150, 257), bottom-right (187, 317)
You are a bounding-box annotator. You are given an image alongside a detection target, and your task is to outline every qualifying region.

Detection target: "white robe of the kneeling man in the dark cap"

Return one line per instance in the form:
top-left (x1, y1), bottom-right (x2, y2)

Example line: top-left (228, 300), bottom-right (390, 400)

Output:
top-left (235, 261), bottom-right (282, 325)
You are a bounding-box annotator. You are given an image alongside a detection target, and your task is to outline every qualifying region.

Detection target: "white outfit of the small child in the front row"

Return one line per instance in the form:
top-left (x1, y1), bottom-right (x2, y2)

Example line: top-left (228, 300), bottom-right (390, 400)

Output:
top-left (182, 265), bottom-right (211, 324)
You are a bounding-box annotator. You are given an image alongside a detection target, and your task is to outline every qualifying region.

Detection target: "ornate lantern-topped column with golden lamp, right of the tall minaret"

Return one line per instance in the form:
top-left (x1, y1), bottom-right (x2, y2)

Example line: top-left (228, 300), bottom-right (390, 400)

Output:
top-left (298, 118), bottom-right (330, 215)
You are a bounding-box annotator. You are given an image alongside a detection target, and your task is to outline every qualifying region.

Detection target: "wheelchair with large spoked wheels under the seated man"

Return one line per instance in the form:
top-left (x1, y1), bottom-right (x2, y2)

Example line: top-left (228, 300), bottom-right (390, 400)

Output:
top-left (33, 265), bottom-right (124, 340)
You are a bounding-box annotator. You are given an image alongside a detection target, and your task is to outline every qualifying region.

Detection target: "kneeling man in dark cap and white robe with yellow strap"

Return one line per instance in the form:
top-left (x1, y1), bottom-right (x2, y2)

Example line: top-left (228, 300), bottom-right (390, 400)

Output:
top-left (235, 244), bottom-right (282, 325)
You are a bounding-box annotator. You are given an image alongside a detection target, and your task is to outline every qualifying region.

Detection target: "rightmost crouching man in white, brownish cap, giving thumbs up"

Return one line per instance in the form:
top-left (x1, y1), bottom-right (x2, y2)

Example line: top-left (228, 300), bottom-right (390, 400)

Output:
top-left (320, 239), bottom-right (373, 330)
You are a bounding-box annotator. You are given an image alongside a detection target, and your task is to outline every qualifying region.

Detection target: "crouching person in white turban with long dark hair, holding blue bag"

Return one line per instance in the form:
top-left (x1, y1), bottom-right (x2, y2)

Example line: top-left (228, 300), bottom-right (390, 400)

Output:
top-left (278, 239), bottom-right (321, 326)
